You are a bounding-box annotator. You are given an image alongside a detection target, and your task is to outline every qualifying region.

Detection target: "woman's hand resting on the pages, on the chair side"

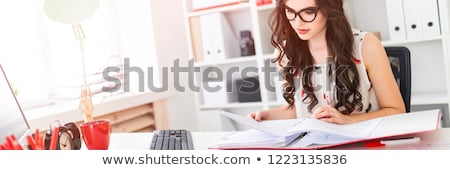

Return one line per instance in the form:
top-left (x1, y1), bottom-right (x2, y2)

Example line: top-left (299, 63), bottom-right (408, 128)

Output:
top-left (312, 105), bottom-right (352, 124)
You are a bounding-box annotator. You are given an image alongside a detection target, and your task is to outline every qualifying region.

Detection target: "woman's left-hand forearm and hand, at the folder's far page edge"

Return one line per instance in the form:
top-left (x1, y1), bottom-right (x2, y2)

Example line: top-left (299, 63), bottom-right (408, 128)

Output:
top-left (248, 104), bottom-right (296, 122)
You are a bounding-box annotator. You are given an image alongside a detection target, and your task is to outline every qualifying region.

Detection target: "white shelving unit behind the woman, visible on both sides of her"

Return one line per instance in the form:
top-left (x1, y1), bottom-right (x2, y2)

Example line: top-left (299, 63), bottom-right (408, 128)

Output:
top-left (183, 0), bottom-right (450, 130)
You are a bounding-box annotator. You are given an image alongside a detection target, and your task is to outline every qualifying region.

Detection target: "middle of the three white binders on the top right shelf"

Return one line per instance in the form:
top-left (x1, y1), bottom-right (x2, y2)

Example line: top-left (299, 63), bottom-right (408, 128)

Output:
top-left (402, 0), bottom-right (423, 39)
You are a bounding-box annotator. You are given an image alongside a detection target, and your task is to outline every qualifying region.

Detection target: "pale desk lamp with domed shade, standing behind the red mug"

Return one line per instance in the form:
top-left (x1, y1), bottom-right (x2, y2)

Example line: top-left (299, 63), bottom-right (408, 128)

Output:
top-left (44, 0), bottom-right (99, 122)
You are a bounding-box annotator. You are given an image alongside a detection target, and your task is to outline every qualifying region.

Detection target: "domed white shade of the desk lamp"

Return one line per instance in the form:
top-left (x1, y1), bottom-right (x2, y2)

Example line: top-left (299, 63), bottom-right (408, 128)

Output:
top-left (44, 0), bottom-right (99, 24)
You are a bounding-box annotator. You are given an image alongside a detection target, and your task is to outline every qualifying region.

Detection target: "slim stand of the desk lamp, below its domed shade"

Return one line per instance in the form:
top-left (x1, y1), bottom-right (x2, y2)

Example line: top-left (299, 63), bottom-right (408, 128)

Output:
top-left (72, 24), bottom-right (94, 122)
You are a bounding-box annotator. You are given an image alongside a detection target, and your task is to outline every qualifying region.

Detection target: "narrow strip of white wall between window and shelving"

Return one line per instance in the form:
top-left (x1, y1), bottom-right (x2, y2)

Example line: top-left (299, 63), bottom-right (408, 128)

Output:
top-left (151, 0), bottom-right (198, 130)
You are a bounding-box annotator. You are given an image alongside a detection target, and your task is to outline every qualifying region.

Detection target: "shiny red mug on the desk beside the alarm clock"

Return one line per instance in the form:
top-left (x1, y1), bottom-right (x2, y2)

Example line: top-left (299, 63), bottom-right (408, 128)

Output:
top-left (80, 119), bottom-right (111, 150)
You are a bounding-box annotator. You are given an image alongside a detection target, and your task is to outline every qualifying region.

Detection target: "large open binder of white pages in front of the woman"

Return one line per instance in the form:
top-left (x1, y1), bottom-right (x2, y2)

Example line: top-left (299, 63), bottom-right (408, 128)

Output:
top-left (210, 110), bottom-right (440, 149)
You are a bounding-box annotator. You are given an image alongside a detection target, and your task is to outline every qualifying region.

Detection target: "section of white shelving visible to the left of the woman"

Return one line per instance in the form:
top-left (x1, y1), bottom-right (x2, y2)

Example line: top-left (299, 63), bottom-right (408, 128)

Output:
top-left (183, 0), bottom-right (275, 131)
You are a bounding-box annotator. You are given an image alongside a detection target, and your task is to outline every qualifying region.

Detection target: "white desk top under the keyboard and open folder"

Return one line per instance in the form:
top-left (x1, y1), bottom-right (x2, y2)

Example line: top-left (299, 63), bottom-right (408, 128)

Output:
top-left (109, 128), bottom-right (450, 150)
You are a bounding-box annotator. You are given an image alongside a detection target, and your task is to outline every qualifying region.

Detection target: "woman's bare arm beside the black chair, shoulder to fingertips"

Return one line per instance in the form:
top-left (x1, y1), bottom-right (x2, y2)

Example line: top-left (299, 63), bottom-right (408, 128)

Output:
top-left (312, 34), bottom-right (405, 124)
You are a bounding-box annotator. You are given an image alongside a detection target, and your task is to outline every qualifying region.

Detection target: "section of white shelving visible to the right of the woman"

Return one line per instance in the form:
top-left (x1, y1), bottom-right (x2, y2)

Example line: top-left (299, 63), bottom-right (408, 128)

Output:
top-left (344, 0), bottom-right (450, 126)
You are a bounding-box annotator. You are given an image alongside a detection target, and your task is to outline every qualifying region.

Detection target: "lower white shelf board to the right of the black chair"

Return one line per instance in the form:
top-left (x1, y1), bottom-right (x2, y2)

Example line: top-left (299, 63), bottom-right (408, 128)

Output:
top-left (411, 92), bottom-right (448, 105)
